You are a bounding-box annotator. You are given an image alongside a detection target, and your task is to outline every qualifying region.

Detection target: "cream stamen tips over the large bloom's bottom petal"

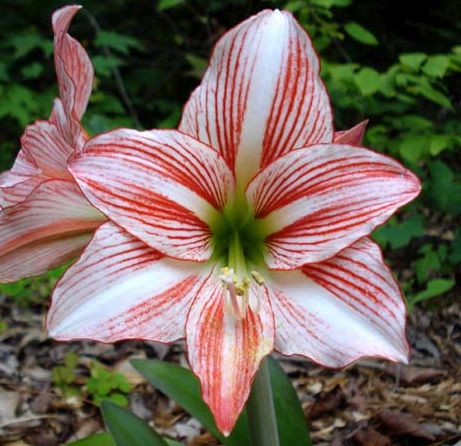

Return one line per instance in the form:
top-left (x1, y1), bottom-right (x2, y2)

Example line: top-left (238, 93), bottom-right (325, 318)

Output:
top-left (219, 266), bottom-right (264, 320)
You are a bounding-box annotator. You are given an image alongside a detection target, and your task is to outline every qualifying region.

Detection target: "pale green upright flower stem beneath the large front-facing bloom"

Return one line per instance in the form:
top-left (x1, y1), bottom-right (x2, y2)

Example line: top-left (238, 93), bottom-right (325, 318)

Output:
top-left (247, 359), bottom-right (280, 446)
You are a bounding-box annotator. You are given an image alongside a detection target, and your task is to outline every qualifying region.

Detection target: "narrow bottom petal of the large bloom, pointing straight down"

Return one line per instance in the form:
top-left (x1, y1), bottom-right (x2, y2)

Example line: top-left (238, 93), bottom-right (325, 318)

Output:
top-left (186, 273), bottom-right (274, 435)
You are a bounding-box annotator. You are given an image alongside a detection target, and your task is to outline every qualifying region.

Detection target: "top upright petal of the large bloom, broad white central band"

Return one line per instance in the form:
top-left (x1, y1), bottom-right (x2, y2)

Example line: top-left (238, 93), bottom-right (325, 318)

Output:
top-left (179, 10), bottom-right (333, 186)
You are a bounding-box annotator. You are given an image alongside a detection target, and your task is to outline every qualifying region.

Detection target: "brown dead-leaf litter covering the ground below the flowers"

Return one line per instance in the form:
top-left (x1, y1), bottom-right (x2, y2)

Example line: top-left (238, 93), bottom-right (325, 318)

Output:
top-left (0, 293), bottom-right (461, 446)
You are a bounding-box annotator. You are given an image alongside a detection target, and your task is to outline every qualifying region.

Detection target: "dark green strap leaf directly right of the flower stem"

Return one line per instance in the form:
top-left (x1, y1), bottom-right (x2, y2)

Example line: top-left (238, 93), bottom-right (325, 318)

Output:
top-left (267, 357), bottom-right (312, 446)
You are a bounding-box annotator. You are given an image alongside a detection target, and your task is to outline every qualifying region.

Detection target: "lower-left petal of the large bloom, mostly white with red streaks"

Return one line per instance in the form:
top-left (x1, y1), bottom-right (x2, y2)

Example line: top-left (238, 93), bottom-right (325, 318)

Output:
top-left (47, 222), bottom-right (201, 342)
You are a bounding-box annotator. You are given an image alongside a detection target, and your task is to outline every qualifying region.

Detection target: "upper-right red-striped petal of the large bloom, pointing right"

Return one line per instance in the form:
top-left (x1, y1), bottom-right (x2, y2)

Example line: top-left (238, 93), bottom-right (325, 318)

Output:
top-left (247, 144), bottom-right (420, 269)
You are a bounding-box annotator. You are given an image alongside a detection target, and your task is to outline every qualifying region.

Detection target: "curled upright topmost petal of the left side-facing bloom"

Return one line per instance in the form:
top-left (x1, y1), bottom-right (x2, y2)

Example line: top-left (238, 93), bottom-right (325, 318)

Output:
top-left (52, 5), bottom-right (94, 120)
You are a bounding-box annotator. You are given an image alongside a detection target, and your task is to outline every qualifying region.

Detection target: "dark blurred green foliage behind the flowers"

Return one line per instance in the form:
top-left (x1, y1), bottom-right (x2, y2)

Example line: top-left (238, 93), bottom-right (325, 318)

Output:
top-left (0, 0), bottom-right (461, 308)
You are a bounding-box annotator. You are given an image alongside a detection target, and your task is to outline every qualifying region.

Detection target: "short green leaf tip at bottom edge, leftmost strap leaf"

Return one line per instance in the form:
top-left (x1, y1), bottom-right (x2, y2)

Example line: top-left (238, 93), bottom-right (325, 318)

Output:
top-left (101, 401), bottom-right (168, 446)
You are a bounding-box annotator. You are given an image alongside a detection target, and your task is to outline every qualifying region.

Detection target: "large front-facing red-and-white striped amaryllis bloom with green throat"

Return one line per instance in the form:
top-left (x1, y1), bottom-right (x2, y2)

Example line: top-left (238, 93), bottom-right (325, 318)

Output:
top-left (47, 10), bottom-right (420, 433)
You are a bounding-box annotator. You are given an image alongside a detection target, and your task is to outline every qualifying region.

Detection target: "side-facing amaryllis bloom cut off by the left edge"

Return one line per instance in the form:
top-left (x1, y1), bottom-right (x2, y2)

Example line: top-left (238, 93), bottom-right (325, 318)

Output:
top-left (0, 6), bottom-right (104, 282)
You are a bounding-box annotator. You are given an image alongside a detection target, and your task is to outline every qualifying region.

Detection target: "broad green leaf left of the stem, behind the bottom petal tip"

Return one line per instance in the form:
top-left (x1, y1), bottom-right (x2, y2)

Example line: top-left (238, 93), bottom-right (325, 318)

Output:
top-left (131, 359), bottom-right (251, 446)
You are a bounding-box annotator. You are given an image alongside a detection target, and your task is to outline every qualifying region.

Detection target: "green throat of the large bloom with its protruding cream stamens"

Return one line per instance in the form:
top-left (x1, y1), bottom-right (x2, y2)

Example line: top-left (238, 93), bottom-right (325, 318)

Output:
top-left (212, 199), bottom-right (265, 319)
